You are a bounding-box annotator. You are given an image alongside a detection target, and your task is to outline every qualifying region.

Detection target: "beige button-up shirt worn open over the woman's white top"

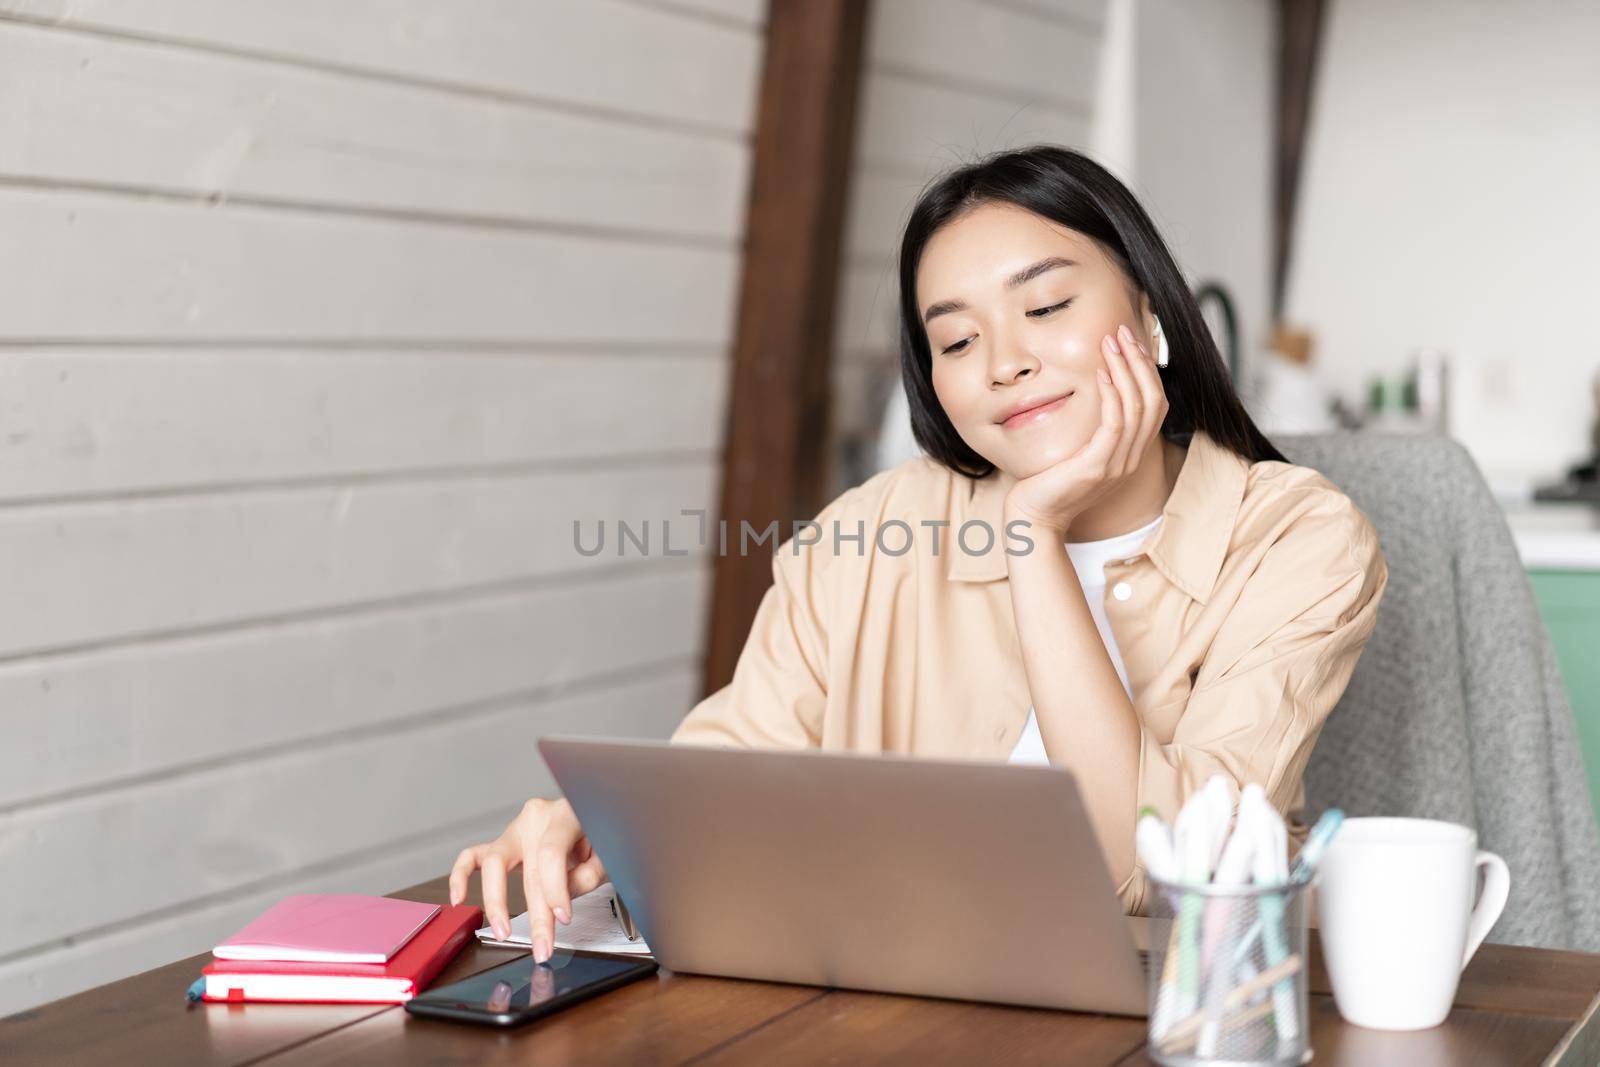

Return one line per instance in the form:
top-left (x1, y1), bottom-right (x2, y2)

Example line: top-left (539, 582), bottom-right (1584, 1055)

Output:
top-left (672, 434), bottom-right (1389, 915)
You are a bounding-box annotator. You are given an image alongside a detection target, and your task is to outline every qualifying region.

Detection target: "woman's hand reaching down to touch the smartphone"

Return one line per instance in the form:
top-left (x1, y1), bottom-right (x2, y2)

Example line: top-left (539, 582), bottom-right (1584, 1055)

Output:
top-left (450, 797), bottom-right (606, 963)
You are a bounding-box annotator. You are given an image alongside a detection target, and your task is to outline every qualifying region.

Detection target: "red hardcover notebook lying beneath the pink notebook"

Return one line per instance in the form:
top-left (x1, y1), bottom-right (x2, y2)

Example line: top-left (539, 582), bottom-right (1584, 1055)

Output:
top-left (200, 904), bottom-right (483, 1005)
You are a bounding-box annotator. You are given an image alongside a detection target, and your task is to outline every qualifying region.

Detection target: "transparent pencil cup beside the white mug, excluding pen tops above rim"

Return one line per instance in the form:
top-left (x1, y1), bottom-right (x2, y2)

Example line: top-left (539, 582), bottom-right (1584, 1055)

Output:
top-left (1147, 878), bottom-right (1310, 1067)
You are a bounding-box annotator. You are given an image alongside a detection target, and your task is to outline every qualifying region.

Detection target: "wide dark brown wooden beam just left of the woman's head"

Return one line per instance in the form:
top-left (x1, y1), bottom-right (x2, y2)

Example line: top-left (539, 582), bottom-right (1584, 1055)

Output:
top-left (704, 0), bottom-right (867, 694)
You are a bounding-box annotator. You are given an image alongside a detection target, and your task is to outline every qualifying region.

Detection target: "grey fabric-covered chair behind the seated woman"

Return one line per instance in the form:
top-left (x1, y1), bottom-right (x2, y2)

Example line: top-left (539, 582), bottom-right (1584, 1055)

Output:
top-left (1277, 434), bottom-right (1600, 952)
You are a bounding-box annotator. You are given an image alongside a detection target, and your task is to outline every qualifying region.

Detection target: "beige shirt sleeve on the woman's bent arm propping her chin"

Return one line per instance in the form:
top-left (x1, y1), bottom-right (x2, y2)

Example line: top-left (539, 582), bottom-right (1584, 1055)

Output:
top-left (1118, 494), bottom-right (1389, 912)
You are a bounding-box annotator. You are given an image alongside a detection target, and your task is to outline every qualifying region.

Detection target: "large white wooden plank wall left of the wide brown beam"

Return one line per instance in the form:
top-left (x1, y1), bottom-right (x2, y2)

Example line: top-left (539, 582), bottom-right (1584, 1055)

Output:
top-left (0, 0), bottom-right (765, 1014)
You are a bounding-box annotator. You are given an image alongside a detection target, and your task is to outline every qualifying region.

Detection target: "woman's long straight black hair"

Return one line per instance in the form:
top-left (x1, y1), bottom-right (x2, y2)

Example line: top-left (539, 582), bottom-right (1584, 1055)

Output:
top-left (899, 144), bottom-right (1283, 478)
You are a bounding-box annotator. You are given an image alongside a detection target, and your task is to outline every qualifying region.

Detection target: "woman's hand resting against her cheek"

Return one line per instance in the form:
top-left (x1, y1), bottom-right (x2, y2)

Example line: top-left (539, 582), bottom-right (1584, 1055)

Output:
top-left (1005, 319), bottom-right (1166, 536)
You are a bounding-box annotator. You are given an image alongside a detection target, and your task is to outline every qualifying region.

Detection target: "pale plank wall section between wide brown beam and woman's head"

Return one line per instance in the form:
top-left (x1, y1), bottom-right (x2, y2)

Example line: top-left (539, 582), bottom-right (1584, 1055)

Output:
top-left (834, 0), bottom-right (1106, 493)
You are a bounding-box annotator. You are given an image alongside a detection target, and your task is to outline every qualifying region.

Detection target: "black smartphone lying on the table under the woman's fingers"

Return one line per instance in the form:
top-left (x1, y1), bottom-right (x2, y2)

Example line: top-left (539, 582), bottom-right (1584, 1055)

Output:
top-left (405, 952), bottom-right (656, 1027)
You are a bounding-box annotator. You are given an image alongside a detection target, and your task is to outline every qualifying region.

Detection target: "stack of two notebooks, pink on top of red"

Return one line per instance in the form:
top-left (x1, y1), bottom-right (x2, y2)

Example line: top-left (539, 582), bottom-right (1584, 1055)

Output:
top-left (200, 894), bottom-right (483, 1003)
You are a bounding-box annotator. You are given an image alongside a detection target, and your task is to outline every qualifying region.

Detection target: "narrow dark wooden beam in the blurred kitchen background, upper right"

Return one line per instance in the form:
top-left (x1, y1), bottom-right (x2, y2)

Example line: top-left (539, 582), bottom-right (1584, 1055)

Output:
top-left (1272, 0), bottom-right (1326, 322)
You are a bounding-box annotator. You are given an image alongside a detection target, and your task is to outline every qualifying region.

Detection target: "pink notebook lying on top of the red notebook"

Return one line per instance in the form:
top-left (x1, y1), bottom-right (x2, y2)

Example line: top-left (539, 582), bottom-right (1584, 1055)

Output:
top-left (211, 893), bottom-right (438, 963)
